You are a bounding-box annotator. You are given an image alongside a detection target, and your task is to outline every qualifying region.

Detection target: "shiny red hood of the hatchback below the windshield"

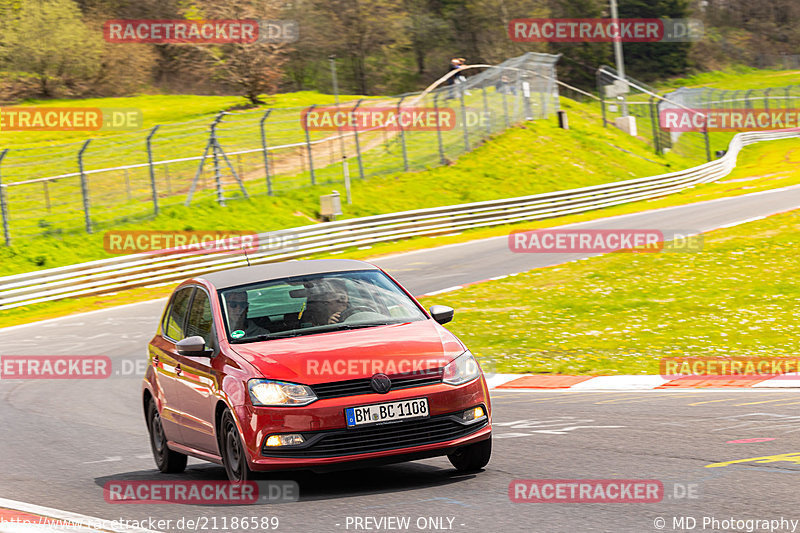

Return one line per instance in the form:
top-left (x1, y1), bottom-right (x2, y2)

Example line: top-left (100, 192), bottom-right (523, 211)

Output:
top-left (231, 319), bottom-right (465, 385)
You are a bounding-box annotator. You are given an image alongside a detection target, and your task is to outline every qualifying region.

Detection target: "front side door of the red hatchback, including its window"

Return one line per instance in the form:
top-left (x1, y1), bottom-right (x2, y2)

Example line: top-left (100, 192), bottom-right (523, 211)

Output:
top-left (175, 287), bottom-right (218, 453)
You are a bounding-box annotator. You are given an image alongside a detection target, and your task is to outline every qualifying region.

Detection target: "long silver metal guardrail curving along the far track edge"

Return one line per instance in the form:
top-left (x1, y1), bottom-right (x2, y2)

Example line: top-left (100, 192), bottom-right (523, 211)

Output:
top-left (0, 128), bottom-right (800, 310)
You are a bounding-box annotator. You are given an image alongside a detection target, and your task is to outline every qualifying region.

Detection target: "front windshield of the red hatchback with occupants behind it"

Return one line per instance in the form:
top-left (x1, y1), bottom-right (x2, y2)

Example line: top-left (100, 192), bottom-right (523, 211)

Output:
top-left (220, 270), bottom-right (426, 343)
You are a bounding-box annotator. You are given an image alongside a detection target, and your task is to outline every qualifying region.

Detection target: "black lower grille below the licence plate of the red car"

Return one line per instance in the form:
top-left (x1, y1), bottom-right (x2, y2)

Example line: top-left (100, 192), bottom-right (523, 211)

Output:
top-left (261, 412), bottom-right (488, 458)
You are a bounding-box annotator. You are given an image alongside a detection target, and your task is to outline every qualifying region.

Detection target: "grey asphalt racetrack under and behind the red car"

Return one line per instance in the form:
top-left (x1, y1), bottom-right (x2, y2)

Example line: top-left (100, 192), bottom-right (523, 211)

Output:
top-left (0, 187), bottom-right (800, 533)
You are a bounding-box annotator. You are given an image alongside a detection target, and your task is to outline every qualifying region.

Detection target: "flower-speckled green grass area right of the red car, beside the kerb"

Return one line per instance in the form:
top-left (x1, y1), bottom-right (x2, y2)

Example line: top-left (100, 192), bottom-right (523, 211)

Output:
top-left (416, 211), bottom-right (800, 375)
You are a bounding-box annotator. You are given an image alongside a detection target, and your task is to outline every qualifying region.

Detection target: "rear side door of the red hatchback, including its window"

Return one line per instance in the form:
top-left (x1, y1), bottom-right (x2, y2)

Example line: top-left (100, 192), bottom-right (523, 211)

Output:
top-left (149, 287), bottom-right (195, 444)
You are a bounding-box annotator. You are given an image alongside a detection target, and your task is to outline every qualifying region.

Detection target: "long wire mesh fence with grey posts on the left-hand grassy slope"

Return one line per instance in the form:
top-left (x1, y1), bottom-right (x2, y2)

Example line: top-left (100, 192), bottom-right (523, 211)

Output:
top-left (0, 53), bottom-right (558, 245)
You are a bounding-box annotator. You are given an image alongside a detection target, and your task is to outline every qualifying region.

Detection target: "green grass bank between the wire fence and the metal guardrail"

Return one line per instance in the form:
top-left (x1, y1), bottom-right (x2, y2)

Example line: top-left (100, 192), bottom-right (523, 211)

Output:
top-left (0, 96), bottom-right (689, 275)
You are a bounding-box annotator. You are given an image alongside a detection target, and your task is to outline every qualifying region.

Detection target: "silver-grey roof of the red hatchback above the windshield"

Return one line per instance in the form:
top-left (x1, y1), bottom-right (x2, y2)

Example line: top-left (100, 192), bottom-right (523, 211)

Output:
top-left (197, 259), bottom-right (379, 289)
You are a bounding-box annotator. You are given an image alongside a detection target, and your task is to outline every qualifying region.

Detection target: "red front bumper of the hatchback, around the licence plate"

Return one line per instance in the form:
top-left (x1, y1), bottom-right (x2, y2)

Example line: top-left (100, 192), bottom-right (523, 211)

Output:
top-left (234, 377), bottom-right (491, 471)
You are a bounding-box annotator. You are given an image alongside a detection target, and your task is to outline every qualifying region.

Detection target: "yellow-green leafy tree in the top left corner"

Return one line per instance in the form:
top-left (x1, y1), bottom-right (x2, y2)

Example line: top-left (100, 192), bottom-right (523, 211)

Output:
top-left (0, 0), bottom-right (102, 98)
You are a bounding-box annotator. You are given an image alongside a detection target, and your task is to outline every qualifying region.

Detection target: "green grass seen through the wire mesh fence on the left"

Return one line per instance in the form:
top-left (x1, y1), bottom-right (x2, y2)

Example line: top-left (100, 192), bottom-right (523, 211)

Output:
top-left (0, 88), bottom-right (568, 240)
